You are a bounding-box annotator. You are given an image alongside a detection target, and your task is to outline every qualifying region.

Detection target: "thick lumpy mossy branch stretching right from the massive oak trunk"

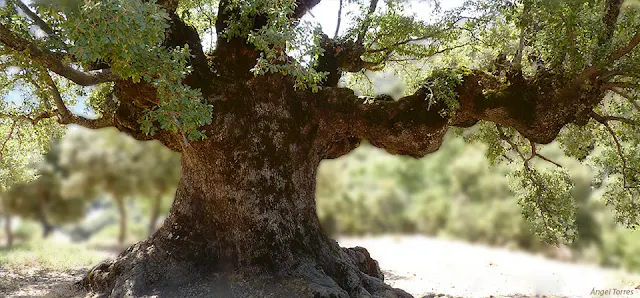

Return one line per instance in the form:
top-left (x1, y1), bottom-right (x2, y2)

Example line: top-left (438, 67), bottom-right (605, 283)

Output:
top-left (314, 71), bottom-right (602, 158)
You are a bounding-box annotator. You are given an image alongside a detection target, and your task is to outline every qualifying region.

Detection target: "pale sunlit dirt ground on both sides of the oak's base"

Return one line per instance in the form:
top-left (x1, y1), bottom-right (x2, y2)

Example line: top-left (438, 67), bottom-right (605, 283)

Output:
top-left (0, 236), bottom-right (640, 298)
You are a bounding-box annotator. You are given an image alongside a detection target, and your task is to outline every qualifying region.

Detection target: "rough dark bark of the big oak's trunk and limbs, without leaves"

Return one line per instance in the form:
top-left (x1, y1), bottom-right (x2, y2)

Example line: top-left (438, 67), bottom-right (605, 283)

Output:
top-left (0, 0), bottom-right (640, 297)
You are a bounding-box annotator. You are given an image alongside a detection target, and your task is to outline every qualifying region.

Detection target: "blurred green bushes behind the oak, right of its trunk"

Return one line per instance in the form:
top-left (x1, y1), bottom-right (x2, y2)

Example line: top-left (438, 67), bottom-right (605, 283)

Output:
top-left (317, 133), bottom-right (640, 270)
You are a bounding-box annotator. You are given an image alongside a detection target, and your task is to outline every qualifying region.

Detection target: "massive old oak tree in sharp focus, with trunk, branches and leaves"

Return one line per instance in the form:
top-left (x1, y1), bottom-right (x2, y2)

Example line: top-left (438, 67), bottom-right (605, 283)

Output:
top-left (0, 0), bottom-right (640, 297)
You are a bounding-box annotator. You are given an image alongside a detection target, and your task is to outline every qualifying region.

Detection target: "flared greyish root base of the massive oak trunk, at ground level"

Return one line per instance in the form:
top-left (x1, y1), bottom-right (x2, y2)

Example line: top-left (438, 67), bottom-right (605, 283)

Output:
top-left (77, 238), bottom-right (412, 298)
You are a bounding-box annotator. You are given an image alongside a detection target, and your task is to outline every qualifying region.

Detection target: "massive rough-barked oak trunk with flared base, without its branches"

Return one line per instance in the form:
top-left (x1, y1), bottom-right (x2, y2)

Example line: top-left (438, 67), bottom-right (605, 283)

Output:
top-left (83, 76), bottom-right (411, 297)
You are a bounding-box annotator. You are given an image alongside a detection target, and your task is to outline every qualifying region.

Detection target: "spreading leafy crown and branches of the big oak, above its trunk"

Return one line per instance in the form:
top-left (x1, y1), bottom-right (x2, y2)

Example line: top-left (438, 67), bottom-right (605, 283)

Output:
top-left (0, 0), bottom-right (640, 241)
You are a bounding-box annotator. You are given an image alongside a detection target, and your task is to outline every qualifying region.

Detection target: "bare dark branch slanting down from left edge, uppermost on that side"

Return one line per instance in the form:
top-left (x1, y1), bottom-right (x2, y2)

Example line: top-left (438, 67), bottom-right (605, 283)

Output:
top-left (0, 24), bottom-right (117, 86)
